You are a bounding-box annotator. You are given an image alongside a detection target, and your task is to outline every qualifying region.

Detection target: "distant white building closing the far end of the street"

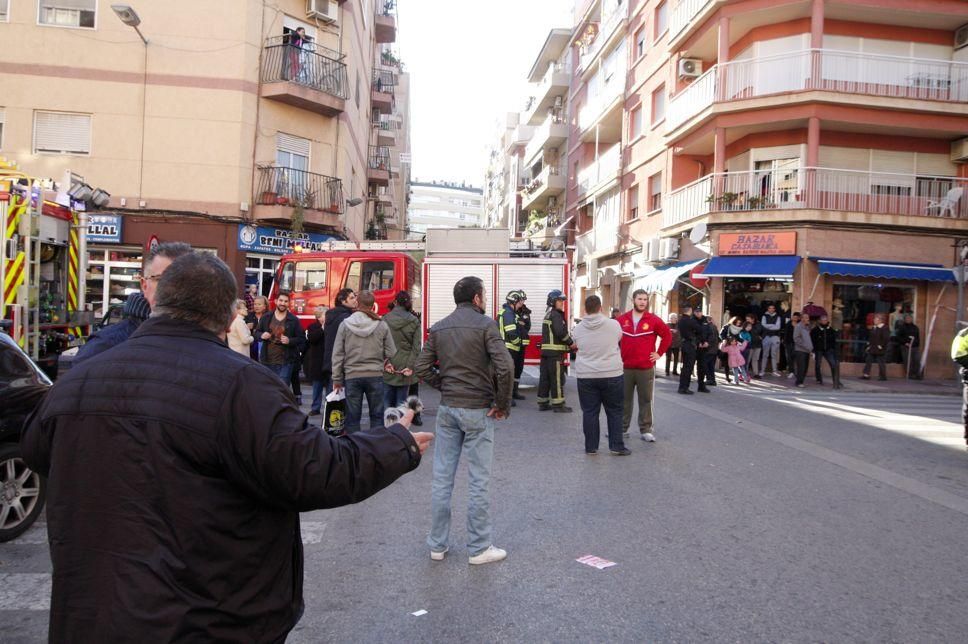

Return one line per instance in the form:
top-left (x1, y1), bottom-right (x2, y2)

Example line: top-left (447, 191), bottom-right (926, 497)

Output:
top-left (407, 179), bottom-right (484, 239)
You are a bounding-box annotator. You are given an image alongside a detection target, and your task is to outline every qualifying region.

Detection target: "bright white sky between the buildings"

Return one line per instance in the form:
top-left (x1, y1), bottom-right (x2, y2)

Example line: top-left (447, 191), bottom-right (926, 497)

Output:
top-left (397, 0), bottom-right (574, 187)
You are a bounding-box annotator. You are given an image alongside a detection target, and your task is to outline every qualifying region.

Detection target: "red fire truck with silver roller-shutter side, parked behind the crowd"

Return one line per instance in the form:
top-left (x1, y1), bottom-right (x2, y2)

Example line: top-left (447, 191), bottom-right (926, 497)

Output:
top-left (270, 228), bottom-right (571, 364)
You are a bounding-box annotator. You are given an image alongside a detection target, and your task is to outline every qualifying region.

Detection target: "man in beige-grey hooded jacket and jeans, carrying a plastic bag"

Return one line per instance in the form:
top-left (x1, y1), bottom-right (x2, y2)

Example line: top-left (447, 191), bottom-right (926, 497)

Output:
top-left (333, 291), bottom-right (397, 434)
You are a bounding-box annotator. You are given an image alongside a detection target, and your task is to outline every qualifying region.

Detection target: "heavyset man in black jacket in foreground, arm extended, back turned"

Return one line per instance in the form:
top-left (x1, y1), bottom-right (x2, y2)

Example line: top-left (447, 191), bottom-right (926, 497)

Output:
top-left (21, 253), bottom-right (431, 642)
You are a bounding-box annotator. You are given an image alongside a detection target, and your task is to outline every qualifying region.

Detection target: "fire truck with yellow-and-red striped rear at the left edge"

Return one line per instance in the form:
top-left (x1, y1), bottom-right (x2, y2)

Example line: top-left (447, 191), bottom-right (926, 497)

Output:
top-left (0, 159), bottom-right (91, 377)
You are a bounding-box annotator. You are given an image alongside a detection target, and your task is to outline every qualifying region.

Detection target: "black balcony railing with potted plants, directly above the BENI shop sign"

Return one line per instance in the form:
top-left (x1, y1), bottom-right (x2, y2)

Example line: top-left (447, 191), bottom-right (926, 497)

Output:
top-left (254, 166), bottom-right (345, 214)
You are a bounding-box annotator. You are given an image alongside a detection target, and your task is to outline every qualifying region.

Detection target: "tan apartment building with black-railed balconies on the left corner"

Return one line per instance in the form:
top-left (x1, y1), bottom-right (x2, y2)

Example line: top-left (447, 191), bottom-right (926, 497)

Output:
top-left (0, 0), bottom-right (409, 310)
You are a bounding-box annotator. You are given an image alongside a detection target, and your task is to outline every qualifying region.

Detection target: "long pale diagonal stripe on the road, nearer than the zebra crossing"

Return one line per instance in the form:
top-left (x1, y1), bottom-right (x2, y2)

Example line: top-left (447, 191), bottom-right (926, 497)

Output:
top-left (658, 393), bottom-right (968, 516)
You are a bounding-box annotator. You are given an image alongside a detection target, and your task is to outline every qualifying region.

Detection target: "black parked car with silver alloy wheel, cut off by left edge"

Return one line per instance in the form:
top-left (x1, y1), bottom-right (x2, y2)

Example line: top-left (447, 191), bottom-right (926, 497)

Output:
top-left (0, 321), bottom-right (51, 542)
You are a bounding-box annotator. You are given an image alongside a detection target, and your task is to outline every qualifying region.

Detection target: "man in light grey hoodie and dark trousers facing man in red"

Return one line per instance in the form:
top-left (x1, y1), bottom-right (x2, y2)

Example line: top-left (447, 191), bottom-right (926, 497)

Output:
top-left (572, 294), bottom-right (628, 456)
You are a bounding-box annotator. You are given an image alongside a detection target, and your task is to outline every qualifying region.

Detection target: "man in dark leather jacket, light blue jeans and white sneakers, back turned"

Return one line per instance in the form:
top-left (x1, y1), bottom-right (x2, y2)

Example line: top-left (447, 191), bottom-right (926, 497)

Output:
top-left (414, 277), bottom-right (514, 564)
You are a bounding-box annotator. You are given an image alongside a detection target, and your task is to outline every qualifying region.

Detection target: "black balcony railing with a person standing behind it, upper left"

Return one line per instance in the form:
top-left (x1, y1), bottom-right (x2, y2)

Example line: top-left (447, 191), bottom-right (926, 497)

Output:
top-left (262, 44), bottom-right (349, 99)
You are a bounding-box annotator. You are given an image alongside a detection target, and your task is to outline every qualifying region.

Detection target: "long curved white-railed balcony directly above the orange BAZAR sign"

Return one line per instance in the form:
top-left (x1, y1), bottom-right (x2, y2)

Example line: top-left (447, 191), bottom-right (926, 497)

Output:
top-left (662, 168), bottom-right (968, 229)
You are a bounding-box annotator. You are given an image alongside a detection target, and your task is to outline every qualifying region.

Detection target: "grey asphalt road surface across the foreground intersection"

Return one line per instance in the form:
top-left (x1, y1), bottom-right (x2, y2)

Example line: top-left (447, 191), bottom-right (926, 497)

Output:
top-left (0, 372), bottom-right (968, 642)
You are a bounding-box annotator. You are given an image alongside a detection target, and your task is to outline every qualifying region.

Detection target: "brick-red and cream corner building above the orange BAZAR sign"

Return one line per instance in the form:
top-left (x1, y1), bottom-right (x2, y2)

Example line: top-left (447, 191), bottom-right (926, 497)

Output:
top-left (492, 0), bottom-right (968, 377)
